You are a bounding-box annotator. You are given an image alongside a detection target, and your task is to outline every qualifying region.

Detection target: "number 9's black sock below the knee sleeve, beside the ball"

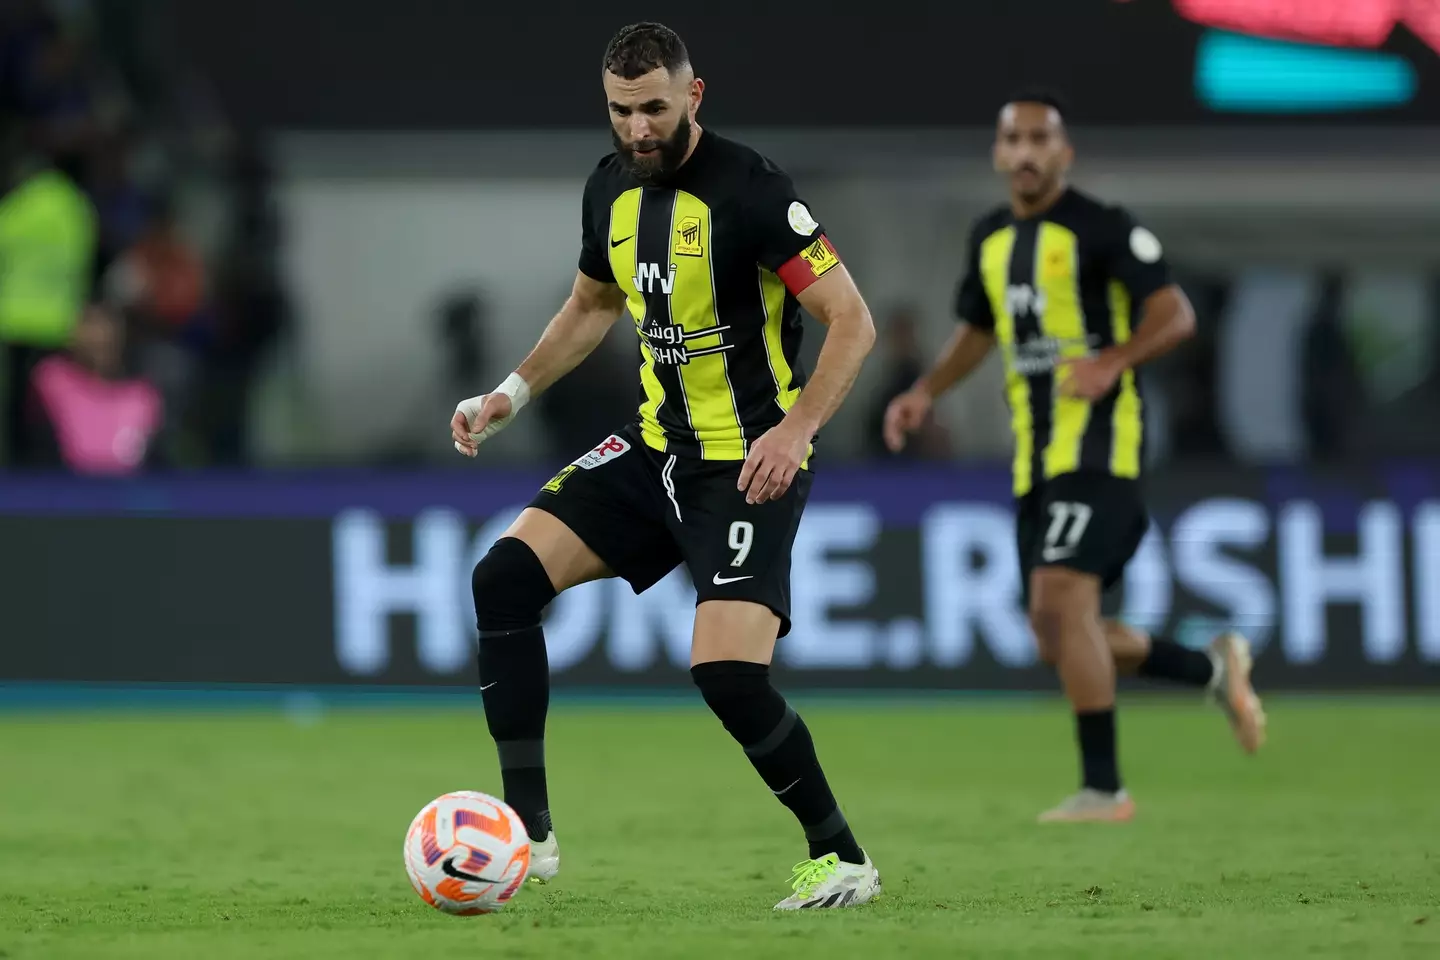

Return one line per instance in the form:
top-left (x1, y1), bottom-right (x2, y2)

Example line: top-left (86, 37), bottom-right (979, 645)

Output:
top-left (480, 626), bottom-right (550, 841)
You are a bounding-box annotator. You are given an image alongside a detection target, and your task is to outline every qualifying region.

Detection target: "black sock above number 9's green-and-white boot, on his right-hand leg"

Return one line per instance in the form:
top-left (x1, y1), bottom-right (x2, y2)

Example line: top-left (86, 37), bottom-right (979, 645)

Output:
top-left (690, 661), bottom-right (865, 864)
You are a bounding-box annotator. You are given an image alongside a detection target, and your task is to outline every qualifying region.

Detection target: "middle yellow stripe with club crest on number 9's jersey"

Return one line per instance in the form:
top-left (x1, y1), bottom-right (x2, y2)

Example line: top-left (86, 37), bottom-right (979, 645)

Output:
top-left (670, 190), bottom-right (744, 461)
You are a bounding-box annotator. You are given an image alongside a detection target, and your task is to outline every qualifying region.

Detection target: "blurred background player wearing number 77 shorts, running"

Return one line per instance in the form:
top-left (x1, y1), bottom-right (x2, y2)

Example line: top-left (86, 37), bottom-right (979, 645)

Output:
top-left (884, 91), bottom-right (1264, 822)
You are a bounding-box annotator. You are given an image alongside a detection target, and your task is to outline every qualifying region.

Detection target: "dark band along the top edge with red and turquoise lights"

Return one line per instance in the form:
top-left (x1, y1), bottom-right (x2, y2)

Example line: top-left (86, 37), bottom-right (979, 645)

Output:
top-left (167, 0), bottom-right (1440, 130)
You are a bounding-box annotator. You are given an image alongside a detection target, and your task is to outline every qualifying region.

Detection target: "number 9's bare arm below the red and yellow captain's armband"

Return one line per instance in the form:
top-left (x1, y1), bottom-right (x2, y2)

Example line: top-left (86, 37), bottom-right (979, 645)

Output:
top-left (740, 263), bottom-right (876, 504)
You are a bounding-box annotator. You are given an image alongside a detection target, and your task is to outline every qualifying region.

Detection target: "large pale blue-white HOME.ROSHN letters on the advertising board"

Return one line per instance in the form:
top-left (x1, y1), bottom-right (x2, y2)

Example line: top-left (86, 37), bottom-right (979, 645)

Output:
top-left (333, 498), bottom-right (1440, 676)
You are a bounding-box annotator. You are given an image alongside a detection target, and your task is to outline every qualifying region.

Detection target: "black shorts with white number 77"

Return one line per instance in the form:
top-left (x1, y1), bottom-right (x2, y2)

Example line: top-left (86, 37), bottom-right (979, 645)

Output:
top-left (1015, 471), bottom-right (1151, 609)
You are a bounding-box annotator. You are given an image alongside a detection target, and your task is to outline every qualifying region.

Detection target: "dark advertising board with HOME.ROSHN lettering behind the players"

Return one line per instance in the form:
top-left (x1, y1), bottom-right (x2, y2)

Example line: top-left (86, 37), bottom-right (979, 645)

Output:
top-left (0, 465), bottom-right (1440, 689)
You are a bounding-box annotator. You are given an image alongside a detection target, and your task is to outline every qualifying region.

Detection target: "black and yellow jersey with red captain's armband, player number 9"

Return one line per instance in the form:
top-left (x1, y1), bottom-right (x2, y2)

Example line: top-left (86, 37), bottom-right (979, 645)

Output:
top-left (580, 131), bottom-right (840, 461)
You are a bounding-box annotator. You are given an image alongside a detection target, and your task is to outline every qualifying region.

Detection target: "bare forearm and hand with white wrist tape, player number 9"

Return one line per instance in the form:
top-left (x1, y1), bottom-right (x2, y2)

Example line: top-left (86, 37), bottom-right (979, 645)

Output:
top-left (451, 272), bottom-right (625, 456)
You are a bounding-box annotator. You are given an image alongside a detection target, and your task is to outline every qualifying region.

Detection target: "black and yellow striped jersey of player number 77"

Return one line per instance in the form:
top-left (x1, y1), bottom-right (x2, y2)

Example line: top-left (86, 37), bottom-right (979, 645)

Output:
top-left (955, 190), bottom-right (1171, 497)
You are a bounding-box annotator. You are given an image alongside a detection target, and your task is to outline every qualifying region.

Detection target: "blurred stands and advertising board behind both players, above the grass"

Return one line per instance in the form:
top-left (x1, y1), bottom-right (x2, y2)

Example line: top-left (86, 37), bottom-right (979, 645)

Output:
top-left (0, 0), bottom-right (1440, 694)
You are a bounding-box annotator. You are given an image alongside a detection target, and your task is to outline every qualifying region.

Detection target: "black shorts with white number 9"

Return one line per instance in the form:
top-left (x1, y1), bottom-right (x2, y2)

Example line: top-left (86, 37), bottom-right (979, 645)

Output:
top-left (530, 425), bottom-right (814, 636)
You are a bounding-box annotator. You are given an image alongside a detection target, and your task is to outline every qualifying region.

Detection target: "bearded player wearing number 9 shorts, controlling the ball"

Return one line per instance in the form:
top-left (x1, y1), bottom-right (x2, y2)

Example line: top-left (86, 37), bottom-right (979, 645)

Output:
top-left (451, 23), bottom-right (880, 910)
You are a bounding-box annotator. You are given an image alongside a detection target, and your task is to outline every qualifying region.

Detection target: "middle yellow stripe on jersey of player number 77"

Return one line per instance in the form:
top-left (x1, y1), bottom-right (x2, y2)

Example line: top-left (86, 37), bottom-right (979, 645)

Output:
top-left (1035, 222), bottom-right (1090, 479)
